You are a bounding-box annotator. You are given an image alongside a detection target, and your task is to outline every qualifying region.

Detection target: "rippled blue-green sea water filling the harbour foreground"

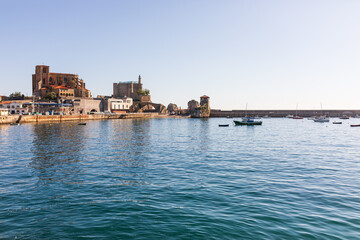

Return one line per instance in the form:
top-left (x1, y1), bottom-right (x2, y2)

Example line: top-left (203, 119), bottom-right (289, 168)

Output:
top-left (0, 119), bottom-right (360, 239)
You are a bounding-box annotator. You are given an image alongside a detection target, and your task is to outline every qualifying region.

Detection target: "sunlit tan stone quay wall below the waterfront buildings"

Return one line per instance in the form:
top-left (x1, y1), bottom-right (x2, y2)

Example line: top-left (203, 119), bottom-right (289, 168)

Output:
top-left (0, 113), bottom-right (178, 124)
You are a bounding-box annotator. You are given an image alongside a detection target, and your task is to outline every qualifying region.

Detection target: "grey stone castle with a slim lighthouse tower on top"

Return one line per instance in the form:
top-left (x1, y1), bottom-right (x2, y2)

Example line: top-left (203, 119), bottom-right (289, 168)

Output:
top-left (113, 75), bottom-right (151, 102)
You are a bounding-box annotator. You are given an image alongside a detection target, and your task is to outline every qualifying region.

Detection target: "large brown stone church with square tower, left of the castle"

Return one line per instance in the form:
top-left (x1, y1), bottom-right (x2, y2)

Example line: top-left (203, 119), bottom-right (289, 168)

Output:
top-left (32, 65), bottom-right (91, 99)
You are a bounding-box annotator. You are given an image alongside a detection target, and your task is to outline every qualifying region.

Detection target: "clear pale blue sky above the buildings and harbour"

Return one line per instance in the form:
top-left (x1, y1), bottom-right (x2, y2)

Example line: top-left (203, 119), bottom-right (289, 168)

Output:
top-left (0, 0), bottom-right (360, 109)
